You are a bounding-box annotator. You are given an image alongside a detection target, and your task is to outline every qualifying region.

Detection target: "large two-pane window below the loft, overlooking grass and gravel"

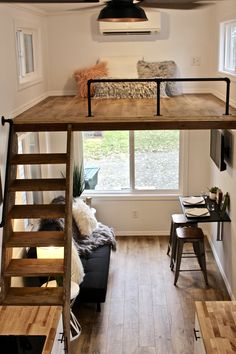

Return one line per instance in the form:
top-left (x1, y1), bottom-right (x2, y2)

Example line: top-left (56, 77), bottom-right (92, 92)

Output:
top-left (83, 130), bottom-right (180, 193)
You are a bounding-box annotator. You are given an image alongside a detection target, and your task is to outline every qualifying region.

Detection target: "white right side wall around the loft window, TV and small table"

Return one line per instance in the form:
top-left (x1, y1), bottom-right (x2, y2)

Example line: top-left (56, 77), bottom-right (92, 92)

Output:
top-left (210, 0), bottom-right (236, 297)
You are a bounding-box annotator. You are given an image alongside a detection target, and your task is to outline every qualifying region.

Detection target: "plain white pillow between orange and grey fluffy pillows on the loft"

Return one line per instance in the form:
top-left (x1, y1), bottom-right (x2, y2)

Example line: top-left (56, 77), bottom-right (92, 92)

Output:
top-left (99, 56), bottom-right (140, 79)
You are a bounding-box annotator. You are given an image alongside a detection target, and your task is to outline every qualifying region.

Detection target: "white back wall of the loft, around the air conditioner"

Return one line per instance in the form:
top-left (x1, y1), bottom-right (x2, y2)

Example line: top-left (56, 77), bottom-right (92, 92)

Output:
top-left (49, 7), bottom-right (211, 93)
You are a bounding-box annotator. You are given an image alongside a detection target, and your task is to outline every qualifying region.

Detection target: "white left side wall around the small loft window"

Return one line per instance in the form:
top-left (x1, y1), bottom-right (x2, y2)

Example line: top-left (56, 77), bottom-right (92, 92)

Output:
top-left (0, 4), bottom-right (48, 266)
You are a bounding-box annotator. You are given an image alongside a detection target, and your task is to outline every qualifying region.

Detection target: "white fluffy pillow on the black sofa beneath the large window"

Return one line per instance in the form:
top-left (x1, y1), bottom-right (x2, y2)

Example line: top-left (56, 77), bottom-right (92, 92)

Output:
top-left (72, 198), bottom-right (98, 236)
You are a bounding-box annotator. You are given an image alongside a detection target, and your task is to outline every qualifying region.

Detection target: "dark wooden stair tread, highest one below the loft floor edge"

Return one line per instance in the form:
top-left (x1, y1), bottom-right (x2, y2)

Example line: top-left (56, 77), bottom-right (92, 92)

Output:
top-left (11, 153), bottom-right (67, 165)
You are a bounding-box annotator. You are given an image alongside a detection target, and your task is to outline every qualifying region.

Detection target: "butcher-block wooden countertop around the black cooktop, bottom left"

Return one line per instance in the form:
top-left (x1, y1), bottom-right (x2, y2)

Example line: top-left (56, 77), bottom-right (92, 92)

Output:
top-left (0, 306), bottom-right (62, 354)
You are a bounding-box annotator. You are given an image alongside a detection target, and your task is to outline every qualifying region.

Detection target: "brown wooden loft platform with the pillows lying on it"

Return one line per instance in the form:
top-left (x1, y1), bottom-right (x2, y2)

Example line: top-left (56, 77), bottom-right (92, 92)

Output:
top-left (14, 57), bottom-right (236, 131)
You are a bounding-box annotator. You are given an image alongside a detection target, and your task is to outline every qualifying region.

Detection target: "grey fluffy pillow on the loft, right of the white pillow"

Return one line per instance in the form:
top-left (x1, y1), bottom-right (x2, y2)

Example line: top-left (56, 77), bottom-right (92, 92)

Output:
top-left (137, 60), bottom-right (182, 96)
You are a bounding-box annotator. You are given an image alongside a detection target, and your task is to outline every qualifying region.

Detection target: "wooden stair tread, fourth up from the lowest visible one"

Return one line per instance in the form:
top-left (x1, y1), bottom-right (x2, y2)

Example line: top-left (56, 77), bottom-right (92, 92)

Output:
top-left (8, 204), bottom-right (65, 219)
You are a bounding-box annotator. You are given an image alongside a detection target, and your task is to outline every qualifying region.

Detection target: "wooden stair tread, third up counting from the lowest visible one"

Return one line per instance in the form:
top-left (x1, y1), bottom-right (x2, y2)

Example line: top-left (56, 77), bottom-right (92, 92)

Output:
top-left (6, 231), bottom-right (64, 247)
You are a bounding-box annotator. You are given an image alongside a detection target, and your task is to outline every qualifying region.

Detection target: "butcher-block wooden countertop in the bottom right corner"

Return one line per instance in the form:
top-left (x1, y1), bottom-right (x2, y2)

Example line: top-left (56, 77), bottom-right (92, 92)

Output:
top-left (195, 301), bottom-right (236, 354)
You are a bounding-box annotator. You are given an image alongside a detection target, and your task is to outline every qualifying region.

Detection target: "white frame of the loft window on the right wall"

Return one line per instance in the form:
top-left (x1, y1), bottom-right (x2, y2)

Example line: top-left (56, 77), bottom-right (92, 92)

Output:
top-left (219, 19), bottom-right (236, 79)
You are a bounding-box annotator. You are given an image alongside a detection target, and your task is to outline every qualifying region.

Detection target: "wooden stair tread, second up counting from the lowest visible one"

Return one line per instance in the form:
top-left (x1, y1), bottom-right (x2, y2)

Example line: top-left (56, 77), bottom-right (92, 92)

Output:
top-left (4, 258), bottom-right (64, 277)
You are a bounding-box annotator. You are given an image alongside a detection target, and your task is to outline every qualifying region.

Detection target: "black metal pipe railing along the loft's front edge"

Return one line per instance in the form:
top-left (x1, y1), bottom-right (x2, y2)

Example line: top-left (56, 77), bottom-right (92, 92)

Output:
top-left (87, 77), bottom-right (230, 117)
